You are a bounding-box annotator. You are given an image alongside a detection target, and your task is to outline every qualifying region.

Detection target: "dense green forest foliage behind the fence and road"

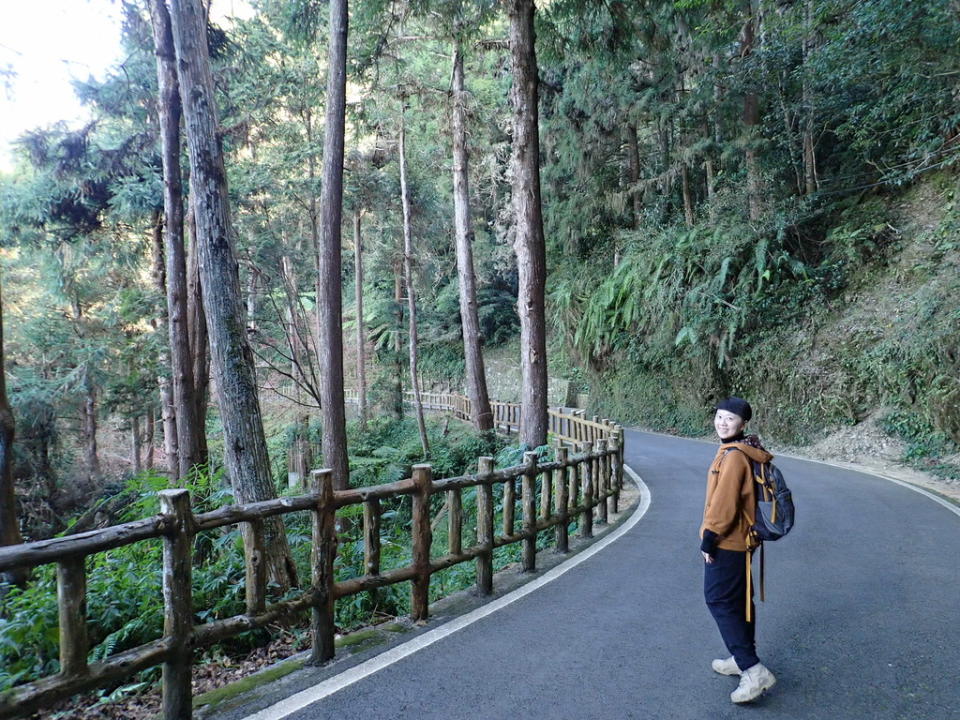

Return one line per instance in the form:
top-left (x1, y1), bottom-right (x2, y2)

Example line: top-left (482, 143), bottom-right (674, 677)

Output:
top-left (0, 0), bottom-right (960, 708)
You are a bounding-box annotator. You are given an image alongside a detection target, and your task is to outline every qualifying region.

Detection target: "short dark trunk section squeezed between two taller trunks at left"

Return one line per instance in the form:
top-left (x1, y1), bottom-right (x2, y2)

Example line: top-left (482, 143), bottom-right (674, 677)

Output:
top-left (187, 195), bottom-right (210, 465)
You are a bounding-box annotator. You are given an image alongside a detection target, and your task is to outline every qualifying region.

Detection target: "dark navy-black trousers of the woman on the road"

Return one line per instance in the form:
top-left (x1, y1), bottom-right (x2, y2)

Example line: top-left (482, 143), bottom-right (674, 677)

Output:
top-left (703, 549), bottom-right (760, 671)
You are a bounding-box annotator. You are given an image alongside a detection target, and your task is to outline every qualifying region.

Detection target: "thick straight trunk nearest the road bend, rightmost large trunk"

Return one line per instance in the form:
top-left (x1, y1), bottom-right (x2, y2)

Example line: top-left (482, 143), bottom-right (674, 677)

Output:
top-left (508, 0), bottom-right (547, 448)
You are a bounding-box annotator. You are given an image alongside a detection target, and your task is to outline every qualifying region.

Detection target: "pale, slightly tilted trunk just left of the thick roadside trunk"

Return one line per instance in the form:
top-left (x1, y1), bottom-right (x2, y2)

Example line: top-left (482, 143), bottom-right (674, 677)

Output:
top-left (452, 45), bottom-right (493, 432)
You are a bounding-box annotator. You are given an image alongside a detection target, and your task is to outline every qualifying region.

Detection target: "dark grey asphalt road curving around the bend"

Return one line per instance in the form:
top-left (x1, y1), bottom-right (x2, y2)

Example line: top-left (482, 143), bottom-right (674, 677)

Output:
top-left (219, 431), bottom-right (960, 720)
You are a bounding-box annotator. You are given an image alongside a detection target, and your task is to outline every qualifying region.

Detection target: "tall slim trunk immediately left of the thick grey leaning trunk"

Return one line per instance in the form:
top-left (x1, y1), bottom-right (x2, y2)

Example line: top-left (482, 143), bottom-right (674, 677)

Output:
top-left (150, 0), bottom-right (203, 478)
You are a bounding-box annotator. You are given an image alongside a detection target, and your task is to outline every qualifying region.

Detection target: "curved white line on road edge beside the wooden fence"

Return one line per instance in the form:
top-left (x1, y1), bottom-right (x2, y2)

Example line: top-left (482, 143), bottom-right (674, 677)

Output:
top-left (244, 464), bottom-right (650, 720)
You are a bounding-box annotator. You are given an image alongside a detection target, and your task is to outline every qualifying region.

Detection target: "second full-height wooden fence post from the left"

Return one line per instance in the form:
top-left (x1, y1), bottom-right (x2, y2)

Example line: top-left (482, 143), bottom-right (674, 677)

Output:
top-left (307, 468), bottom-right (337, 665)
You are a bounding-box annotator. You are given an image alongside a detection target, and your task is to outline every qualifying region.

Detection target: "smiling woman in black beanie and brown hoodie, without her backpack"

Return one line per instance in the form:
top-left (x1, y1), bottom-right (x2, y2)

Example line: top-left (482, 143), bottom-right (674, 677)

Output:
top-left (700, 397), bottom-right (777, 703)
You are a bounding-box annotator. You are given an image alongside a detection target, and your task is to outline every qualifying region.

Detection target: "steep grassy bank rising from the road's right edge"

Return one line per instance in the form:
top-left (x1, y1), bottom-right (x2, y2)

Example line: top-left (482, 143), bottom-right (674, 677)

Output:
top-left (591, 173), bottom-right (960, 494)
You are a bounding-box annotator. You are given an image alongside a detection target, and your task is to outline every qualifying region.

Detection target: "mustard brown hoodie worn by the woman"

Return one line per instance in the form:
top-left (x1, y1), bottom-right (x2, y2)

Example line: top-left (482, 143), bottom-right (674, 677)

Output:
top-left (700, 441), bottom-right (773, 554)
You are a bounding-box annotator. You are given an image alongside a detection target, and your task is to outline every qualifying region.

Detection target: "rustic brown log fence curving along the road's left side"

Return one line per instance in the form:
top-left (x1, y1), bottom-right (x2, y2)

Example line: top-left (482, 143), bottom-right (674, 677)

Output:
top-left (0, 400), bottom-right (624, 720)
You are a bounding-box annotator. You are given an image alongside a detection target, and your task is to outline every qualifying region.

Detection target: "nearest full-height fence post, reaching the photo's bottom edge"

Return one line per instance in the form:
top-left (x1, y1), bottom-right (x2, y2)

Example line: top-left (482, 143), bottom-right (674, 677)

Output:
top-left (158, 490), bottom-right (193, 720)
